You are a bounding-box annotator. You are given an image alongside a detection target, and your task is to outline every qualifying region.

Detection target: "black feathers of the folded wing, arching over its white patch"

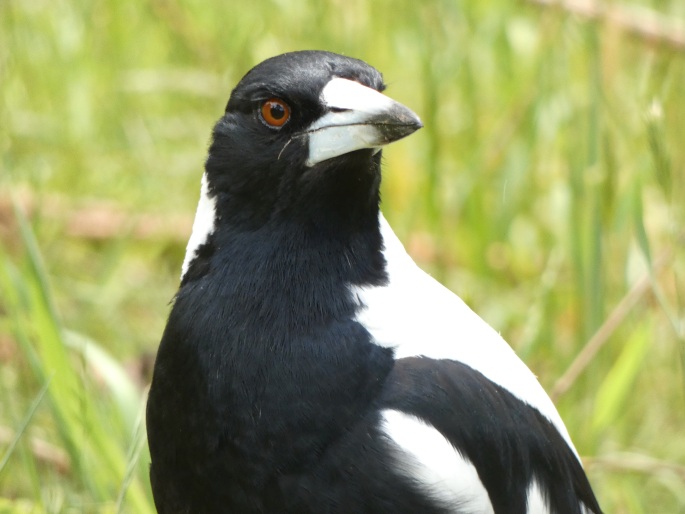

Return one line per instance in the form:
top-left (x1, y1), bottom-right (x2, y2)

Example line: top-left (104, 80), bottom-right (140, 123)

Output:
top-left (382, 357), bottom-right (601, 514)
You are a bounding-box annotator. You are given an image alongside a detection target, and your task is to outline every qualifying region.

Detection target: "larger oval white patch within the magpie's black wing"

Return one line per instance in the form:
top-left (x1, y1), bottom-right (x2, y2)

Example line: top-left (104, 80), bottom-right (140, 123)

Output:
top-left (381, 409), bottom-right (494, 514)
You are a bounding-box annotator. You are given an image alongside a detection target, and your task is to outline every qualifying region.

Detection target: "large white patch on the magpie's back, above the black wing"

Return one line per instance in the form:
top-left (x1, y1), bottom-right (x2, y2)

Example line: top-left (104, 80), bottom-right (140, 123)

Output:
top-left (351, 215), bottom-right (577, 456)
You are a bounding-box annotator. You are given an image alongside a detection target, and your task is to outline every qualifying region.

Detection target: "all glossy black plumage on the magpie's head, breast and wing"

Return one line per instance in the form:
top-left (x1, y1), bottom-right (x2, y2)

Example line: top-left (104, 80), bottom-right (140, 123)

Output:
top-left (147, 52), bottom-right (599, 514)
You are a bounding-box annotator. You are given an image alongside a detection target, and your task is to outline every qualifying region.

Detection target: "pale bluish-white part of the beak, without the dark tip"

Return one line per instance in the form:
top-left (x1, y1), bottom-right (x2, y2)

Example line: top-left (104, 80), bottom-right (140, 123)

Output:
top-left (307, 77), bottom-right (397, 166)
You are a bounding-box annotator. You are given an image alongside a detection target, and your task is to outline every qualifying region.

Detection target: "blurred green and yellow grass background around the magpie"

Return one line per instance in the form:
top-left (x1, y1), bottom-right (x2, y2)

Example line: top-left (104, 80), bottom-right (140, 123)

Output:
top-left (0, 0), bottom-right (685, 513)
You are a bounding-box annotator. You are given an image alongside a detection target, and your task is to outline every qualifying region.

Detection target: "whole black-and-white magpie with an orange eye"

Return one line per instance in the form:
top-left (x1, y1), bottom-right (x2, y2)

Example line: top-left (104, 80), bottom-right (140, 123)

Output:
top-left (146, 50), bottom-right (601, 514)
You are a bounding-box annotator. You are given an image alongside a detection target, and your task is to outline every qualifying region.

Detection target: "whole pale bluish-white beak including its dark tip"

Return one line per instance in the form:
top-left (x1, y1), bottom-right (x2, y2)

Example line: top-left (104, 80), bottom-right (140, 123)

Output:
top-left (306, 77), bottom-right (423, 166)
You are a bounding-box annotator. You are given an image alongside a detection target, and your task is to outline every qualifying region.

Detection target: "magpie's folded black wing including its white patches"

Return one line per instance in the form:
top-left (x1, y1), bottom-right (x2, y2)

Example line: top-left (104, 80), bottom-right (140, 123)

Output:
top-left (381, 357), bottom-right (599, 514)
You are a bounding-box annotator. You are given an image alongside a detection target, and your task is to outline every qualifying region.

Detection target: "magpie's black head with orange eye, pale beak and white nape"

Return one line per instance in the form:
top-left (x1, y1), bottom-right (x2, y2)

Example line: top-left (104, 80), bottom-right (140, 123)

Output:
top-left (179, 51), bottom-right (422, 280)
